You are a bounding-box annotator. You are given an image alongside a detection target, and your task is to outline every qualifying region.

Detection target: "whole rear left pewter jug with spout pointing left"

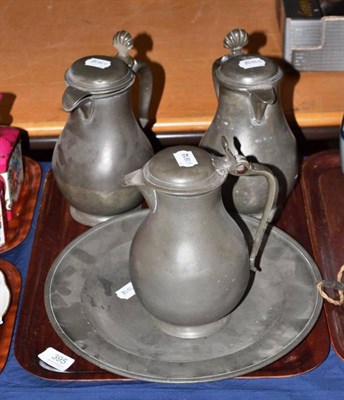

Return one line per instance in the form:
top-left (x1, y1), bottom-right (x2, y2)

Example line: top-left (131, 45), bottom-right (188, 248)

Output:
top-left (52, 31), bottom-right (153, 226)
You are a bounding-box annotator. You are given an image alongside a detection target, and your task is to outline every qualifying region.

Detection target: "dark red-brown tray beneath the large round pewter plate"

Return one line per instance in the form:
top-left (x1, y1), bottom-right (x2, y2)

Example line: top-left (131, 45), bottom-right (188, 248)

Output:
top-left (15, 171), bottom-right (329, 380)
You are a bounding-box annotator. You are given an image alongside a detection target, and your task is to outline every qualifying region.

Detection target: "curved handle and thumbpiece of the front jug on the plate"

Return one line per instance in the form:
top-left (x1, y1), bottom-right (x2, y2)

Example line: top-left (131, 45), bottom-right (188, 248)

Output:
top-left (222, 136), bottom-right (278, 271)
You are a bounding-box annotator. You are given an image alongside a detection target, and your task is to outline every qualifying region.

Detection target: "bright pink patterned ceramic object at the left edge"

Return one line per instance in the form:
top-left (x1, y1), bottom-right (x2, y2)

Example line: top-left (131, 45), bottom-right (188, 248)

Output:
top-left (0, 126), bottom-right (24, 220)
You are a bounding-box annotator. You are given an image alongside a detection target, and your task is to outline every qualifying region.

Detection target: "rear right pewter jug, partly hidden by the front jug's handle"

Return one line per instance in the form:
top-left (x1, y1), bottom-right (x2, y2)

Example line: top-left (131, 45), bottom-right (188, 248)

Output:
top-left (200, 29), bottom-right (298, 219)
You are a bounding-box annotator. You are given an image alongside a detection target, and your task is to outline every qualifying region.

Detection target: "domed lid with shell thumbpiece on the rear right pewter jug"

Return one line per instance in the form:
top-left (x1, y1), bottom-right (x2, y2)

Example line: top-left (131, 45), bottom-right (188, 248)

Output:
top-left (215, 29), bottom-right (283, 89)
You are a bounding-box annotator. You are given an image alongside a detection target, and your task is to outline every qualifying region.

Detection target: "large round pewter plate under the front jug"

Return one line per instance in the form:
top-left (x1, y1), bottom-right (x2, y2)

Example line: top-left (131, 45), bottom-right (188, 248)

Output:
top-left (45, 210), bottom-right (322, 383)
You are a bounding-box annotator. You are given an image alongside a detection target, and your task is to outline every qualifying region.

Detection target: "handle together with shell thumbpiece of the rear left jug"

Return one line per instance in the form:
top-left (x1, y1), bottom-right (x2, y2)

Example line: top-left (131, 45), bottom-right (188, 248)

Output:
top-left (112, 31), bottom-right (153, 128)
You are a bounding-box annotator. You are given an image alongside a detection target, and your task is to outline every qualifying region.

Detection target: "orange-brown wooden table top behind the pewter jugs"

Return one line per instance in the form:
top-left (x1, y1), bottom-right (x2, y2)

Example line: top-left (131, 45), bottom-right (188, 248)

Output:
top-left (0, 0), bottom-right (344, 137)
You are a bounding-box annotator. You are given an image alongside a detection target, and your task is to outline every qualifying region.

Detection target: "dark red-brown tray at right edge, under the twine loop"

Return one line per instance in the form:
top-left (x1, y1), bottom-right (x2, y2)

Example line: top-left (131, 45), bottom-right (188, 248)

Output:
top-left (301, 151), bottom-right (344, 359)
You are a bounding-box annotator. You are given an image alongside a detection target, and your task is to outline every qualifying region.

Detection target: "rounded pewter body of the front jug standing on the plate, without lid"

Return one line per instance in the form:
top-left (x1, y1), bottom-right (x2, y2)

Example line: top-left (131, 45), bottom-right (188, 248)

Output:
top-left (130, 188), bottom-right (250, 338)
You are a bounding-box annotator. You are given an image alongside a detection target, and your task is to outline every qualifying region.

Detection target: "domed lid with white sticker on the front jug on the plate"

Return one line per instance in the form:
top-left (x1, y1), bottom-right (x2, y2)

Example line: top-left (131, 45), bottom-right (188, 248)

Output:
top-left (143, 145), bottom-right (225, 195)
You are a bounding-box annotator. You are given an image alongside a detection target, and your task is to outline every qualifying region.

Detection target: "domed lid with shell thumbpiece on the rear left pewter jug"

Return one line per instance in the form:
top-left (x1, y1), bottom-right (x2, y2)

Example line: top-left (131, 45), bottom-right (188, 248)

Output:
top-left (65, 31), bottom-right (135, 94)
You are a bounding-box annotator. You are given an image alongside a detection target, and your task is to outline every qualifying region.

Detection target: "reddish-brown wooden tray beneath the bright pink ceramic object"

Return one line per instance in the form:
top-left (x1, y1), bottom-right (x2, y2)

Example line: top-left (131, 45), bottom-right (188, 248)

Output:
top-left (0, 157), bottom-right (42, 253)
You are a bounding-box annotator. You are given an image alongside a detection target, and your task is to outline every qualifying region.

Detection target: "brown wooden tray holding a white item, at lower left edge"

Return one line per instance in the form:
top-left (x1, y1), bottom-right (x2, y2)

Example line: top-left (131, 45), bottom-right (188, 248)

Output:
top-left (0, 260), bottom-right (21, 372)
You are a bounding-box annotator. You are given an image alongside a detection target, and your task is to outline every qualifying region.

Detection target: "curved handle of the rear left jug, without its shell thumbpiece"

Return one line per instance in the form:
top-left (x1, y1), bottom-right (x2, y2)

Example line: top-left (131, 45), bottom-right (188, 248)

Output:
top-left (132, 60), bottom-right (153, 128)
